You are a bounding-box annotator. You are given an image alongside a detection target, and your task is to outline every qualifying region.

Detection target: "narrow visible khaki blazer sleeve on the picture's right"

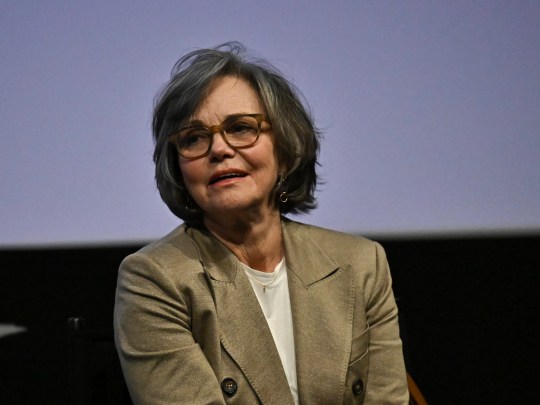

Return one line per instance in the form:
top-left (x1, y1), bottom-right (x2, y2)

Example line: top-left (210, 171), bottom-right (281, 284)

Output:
top-left (364, 244), bottom-right (409, 404)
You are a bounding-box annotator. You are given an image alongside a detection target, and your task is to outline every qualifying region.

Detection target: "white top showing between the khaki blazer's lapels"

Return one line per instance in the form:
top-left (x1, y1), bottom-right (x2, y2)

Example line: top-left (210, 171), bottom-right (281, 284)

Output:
top-left (242, 259), bottom-right (298, 405)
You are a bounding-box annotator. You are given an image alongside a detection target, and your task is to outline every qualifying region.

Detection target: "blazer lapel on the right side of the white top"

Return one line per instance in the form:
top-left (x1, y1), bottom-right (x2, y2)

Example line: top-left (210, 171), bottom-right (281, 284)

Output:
top-left (283, 220), bottom-right (354, 404)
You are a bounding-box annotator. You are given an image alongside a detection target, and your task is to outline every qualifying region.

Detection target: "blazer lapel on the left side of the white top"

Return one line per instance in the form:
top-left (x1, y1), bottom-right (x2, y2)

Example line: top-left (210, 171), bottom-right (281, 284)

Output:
top-left (190, 226), bottom-right (294, 404)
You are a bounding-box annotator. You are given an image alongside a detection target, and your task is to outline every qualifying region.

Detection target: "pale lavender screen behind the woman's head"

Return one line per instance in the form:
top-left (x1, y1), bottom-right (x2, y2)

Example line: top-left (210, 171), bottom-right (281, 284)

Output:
top-left (0, 0), bottom-right (540, 247)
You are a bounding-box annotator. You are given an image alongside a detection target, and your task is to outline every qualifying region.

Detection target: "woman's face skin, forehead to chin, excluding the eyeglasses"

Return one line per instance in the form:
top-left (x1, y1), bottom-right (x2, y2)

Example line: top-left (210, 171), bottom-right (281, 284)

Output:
top-left (179, 76), bottom-right (279, 221)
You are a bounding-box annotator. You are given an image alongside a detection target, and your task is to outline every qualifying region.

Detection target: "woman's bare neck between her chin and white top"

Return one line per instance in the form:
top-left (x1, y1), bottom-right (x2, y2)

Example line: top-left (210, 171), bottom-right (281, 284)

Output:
top-left (204, 210), bottom-right (284, 272)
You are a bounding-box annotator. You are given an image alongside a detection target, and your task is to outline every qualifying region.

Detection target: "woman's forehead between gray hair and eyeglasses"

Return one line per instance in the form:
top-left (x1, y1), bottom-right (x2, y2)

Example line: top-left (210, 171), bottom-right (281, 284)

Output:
top-left (193, 76), bottom-right (264, 124)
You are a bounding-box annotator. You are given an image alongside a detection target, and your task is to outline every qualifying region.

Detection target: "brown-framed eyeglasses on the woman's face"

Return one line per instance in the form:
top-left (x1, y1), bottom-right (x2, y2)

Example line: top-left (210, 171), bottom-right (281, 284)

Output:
top-left (169, 114), bottom-right (270, 160)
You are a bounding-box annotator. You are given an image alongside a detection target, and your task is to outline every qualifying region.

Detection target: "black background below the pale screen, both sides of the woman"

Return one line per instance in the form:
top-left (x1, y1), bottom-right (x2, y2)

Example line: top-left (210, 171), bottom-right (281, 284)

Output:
top-left (0, 235), bottom-right (540, 405)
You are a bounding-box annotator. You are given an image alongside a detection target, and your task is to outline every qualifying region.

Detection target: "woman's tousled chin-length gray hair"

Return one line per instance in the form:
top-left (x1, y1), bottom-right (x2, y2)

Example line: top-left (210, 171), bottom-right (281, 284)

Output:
top-left (152, 42), bottom-right (320, 223)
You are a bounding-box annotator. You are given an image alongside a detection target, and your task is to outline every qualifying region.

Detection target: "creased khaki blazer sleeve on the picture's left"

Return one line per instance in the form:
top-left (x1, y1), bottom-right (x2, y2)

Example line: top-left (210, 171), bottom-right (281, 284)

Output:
top-left (114, 253), bottom-right (225, 405)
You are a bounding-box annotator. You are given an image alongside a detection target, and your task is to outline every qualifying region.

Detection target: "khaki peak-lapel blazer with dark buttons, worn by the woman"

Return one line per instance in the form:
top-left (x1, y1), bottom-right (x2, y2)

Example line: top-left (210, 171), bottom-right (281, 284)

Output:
top-left (114, 219), bottom-right (408, 405)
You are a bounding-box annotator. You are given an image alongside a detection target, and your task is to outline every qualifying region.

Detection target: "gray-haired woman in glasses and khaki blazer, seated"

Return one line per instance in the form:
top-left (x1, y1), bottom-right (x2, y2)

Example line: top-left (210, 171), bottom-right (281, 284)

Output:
top-left (115, 43), bottom-right (408, 405)
